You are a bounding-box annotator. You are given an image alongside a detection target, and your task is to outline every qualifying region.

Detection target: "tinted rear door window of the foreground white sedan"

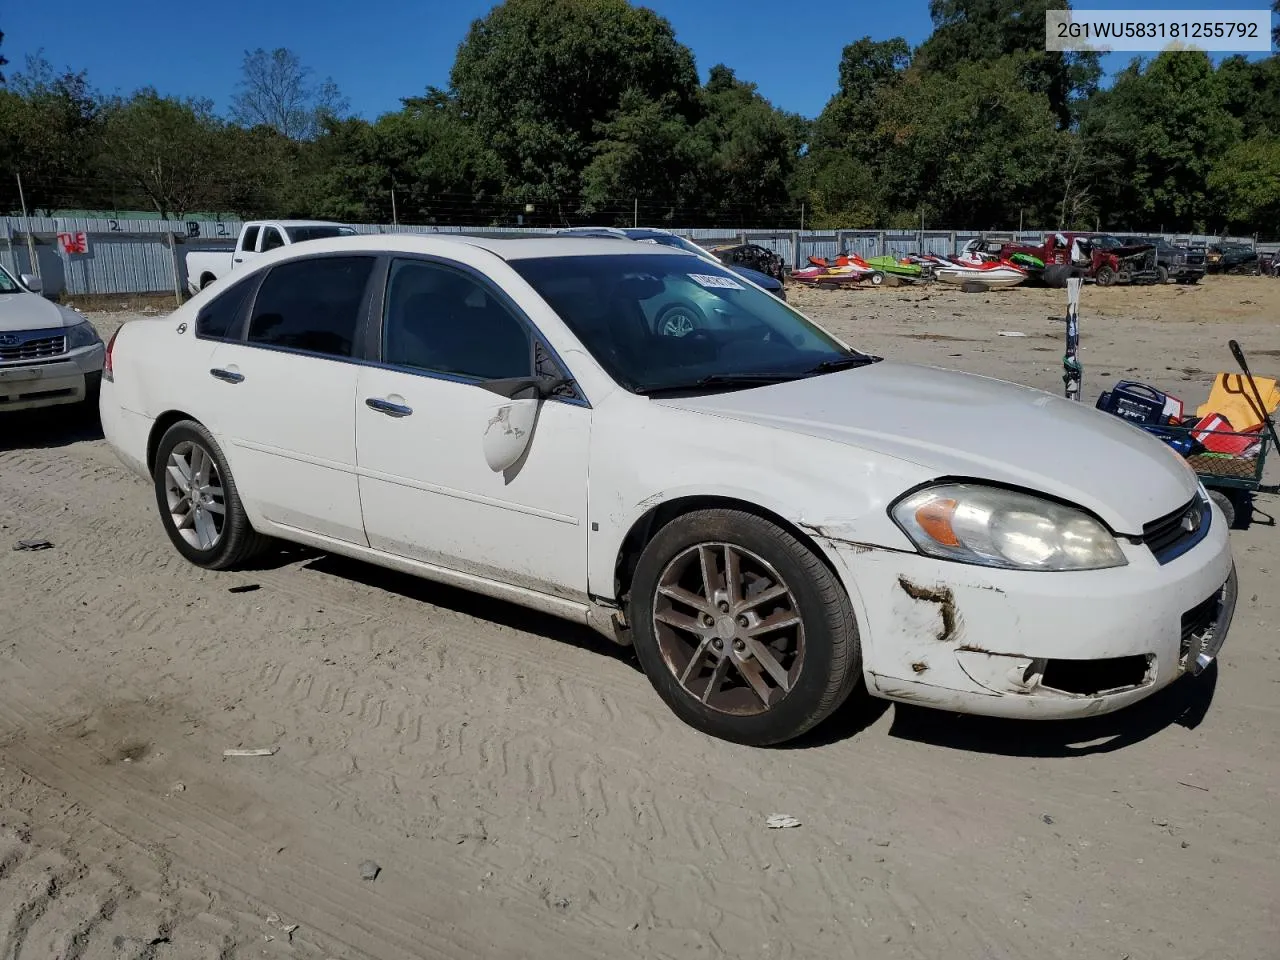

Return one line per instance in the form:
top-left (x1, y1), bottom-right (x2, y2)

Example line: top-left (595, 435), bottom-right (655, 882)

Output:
top-left (248, 257), bottom-right (374, 357)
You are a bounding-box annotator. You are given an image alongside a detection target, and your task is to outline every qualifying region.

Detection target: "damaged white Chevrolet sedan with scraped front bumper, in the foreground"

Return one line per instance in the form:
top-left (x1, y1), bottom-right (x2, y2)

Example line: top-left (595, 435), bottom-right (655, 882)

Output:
top-left (101, 236), bottom-right (1235, 744)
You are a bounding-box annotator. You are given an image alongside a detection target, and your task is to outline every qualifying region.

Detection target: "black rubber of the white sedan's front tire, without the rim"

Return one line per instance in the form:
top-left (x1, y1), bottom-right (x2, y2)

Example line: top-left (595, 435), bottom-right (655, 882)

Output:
top-left (628, 509), bottom-right (861, 746)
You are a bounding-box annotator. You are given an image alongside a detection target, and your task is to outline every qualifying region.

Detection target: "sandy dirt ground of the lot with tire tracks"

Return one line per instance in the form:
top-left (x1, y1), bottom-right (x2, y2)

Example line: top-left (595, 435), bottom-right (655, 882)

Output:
top-left (0, 278), bottom-right (1280, 960)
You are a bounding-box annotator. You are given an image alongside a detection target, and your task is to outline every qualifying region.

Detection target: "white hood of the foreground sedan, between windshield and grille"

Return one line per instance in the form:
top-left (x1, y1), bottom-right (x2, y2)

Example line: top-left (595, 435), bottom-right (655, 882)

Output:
top-left (657, 361), bottom-right (1198, 535)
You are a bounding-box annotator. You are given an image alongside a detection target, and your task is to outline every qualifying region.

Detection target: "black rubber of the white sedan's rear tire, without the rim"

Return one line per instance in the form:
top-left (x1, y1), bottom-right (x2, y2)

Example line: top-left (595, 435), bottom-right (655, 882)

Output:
top-left (151, 420), bottom-right (270, 570)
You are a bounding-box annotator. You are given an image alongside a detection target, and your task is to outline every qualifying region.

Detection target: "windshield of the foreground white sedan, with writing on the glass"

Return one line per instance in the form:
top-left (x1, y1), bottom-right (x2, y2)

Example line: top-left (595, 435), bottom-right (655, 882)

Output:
top-left (511, 253), bottom-right (874, 394)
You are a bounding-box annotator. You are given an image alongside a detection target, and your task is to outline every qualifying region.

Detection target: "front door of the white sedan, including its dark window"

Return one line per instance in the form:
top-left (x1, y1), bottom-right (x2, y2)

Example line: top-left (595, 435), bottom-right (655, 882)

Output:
top-left (356, 259), bottom-right (591, 599)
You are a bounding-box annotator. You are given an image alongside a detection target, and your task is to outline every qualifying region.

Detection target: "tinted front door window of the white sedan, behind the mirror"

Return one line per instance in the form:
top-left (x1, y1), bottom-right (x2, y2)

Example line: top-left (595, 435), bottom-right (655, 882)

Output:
top-left (383, 260), bottom-right (532, 380)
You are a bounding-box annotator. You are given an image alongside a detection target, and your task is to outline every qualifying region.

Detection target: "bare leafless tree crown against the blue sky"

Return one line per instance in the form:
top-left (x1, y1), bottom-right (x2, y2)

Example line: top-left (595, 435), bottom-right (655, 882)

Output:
top-left (232, 47), bottom-right (348, 140)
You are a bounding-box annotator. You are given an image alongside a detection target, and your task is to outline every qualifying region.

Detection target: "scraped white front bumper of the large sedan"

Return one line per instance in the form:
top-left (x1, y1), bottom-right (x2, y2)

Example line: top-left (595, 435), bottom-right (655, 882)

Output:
top-left (823, 508), bottom-right (1235, 718)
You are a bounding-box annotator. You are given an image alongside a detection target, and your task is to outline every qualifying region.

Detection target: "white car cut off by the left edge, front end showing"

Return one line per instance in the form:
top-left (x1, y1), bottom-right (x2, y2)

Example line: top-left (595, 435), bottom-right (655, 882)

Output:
top-left (0, 266), bottom-right (106, 412)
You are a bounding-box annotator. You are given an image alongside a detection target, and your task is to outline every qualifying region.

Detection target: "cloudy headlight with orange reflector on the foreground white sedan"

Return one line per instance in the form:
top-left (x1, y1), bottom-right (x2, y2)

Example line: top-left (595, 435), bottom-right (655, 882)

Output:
top-left (892, 484), bottom-right (1128, 571)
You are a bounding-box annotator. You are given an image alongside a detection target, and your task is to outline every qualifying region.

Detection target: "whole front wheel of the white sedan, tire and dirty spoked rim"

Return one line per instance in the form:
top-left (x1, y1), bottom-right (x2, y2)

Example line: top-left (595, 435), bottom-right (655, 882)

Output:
top-left (628, 509), bottom-right (861, 746)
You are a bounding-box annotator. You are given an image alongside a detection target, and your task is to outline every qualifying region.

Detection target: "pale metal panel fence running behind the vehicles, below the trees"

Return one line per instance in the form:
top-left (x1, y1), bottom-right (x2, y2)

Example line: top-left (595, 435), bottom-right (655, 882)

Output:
top-left (0, 216), bottom-right (1259, 297)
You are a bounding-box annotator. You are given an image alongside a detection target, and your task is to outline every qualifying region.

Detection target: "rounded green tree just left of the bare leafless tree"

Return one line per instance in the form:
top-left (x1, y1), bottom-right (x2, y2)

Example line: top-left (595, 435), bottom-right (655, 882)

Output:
top-left (102, 87), bottom-right (224, 219)
